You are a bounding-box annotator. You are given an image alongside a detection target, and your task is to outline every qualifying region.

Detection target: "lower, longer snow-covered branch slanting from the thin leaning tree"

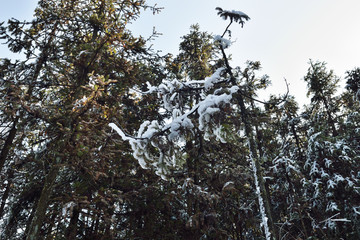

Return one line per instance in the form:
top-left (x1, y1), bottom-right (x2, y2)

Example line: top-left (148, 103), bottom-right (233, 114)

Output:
top-left (109, 81), bottom-right (238, 177)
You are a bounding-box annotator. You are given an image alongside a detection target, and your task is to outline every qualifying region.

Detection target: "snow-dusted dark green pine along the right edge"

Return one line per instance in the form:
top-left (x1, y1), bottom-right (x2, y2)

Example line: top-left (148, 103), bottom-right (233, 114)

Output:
top-left (301, 62), bottom-right (359, 239)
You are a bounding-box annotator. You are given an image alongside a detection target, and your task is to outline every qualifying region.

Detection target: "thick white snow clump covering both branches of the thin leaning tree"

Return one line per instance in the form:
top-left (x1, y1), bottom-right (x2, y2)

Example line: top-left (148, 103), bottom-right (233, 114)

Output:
top-left (109, 68), bottom-right (239, 179)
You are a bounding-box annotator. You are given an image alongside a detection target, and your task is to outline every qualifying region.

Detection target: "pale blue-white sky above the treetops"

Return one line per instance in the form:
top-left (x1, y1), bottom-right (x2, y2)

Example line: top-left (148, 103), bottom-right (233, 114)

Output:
top-left (0, 0), bottom-right (360, 106)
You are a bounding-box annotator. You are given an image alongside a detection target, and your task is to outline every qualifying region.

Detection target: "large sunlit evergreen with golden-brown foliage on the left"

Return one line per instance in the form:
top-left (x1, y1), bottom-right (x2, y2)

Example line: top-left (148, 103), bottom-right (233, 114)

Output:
top-left (1, 0), bottom-right (163, 239)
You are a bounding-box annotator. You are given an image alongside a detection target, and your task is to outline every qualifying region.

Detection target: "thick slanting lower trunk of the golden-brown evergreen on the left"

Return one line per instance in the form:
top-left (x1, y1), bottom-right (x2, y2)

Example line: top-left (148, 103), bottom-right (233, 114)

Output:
top-left (26, 166), bottom-right (59, 240)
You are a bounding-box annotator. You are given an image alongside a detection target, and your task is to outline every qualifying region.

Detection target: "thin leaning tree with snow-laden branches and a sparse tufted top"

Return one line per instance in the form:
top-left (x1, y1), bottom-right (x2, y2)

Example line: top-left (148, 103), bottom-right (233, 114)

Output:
top-left (110, 9), bottom-right (286, 239)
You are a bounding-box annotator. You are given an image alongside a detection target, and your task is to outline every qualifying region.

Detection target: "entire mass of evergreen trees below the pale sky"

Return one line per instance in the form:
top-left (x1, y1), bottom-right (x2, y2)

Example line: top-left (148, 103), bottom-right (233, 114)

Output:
top-left (0, 0), bottom-right (360, 240)
